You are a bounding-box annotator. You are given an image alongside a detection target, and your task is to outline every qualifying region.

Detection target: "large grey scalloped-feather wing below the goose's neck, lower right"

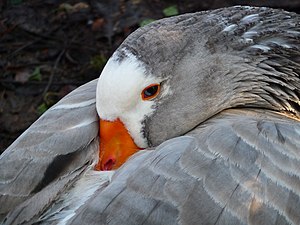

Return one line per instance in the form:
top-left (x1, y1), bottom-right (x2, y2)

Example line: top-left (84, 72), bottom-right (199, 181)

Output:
top-left (70, 109), bottom-right (300, 225)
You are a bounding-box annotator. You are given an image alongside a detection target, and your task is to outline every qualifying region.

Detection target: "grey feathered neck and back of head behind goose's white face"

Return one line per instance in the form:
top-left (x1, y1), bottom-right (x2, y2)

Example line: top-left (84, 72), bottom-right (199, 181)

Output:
top-left (115, 7), bottom-right (300, 145)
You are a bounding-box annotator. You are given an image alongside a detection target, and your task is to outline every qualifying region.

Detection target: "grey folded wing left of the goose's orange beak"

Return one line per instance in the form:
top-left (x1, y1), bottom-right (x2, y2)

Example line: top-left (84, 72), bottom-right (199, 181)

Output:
top-left (0, 80), bottom-right (98, 221)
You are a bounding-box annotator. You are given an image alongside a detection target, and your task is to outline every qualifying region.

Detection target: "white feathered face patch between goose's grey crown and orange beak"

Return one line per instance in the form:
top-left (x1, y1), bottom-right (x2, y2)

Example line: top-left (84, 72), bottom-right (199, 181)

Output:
top-left (96, 50), bottom-right (161, 148)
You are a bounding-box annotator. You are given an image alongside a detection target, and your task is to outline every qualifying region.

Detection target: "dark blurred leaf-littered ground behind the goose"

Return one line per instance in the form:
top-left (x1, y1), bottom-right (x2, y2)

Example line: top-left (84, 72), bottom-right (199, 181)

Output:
top-left (0, 0), bottom-right (300, 152)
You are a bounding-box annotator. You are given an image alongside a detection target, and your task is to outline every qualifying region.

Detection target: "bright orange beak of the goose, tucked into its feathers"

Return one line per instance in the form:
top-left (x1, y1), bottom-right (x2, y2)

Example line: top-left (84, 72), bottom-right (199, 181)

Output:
top-left (95, 119), bottom-right (141, 170)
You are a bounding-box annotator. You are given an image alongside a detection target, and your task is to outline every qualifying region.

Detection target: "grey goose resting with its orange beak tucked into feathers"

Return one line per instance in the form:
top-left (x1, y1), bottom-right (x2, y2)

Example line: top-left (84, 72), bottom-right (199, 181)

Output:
top-left (0, 6), bottom-right (300, 225)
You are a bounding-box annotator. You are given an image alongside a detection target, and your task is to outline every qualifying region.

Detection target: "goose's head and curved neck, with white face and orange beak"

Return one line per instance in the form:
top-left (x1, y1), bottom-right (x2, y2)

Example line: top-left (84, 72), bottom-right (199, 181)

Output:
top-left (96, 7), bottom-right (300, 170)
